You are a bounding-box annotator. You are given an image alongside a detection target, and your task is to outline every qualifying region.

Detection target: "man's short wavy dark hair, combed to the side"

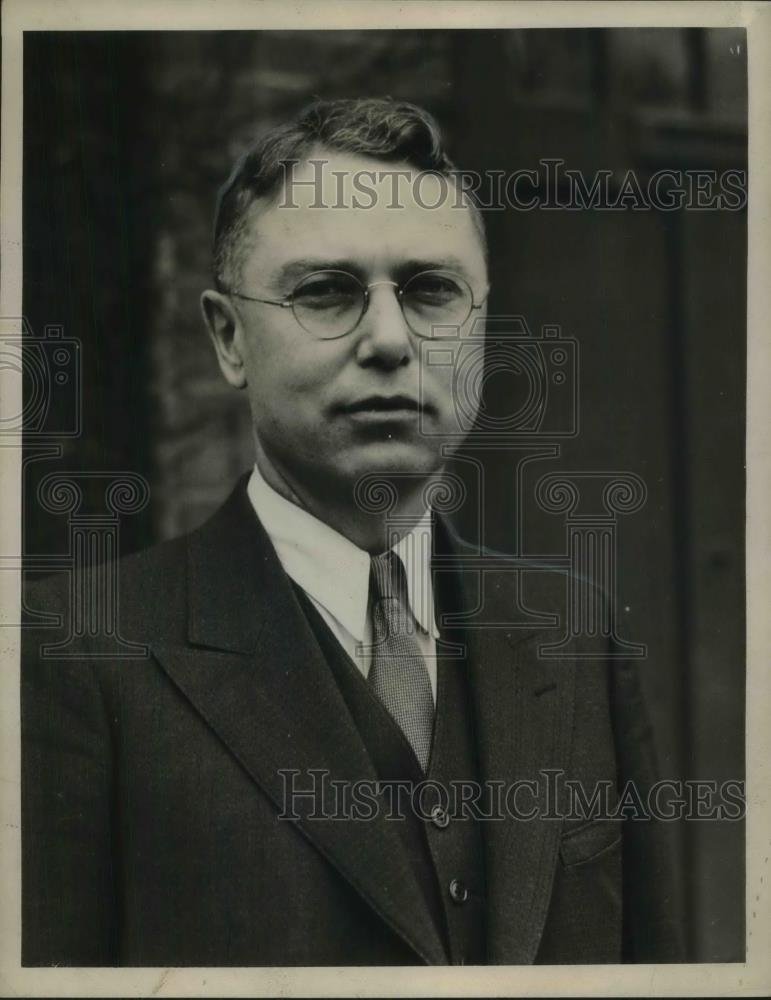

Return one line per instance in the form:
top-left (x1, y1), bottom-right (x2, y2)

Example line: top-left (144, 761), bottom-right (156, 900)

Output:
top-left (213, 97), bottom-right (486, 290)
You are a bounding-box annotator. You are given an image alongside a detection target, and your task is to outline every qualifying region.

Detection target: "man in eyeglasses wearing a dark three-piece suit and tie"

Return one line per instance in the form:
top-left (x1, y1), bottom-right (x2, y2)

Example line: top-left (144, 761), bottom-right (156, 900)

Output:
top-left (22, 100), bottom-right (677, 966)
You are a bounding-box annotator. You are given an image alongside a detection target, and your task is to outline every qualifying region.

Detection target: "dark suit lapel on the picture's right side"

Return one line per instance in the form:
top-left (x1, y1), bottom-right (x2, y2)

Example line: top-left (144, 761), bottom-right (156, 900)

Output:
top-left (444, 545), bottom-right (574, 965)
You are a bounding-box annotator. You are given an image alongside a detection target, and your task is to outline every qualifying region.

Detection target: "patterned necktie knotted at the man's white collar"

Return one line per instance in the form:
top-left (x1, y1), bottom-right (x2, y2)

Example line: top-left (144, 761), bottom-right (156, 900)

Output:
top-left (369, 552), bottom-right (434, 771)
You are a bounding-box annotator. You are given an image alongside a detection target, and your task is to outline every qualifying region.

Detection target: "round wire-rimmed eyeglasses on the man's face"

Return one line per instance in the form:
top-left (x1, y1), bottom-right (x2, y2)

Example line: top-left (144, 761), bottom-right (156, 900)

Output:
top-left (228, 270), bottom-right (488, 340)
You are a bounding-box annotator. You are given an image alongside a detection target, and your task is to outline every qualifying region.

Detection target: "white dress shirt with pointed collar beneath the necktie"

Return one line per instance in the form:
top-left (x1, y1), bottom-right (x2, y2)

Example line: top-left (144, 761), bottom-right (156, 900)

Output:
top-left (247, 464), bottom-right (439, 702)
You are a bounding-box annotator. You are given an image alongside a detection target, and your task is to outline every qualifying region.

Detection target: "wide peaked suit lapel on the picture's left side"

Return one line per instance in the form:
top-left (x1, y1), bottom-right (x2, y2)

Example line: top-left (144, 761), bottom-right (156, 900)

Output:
top-left (152, 479), bottom-right (447, 964)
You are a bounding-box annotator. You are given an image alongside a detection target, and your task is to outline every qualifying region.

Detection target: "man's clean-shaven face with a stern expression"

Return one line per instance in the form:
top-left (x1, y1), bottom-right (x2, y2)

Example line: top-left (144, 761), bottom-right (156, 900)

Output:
top-left (214, 151), bottom-right (487, 500)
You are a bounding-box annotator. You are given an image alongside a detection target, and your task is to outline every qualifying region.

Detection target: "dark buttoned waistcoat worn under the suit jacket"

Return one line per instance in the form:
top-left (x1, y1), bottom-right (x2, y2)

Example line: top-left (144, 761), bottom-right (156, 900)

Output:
top-left (295, 560), bottom-right (485, 965)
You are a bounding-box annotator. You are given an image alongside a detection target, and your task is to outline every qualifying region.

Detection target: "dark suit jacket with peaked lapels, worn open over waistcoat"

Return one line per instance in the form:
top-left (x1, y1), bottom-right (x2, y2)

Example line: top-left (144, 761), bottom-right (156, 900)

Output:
top-left (22, 478), bottom-right (680, 966)
